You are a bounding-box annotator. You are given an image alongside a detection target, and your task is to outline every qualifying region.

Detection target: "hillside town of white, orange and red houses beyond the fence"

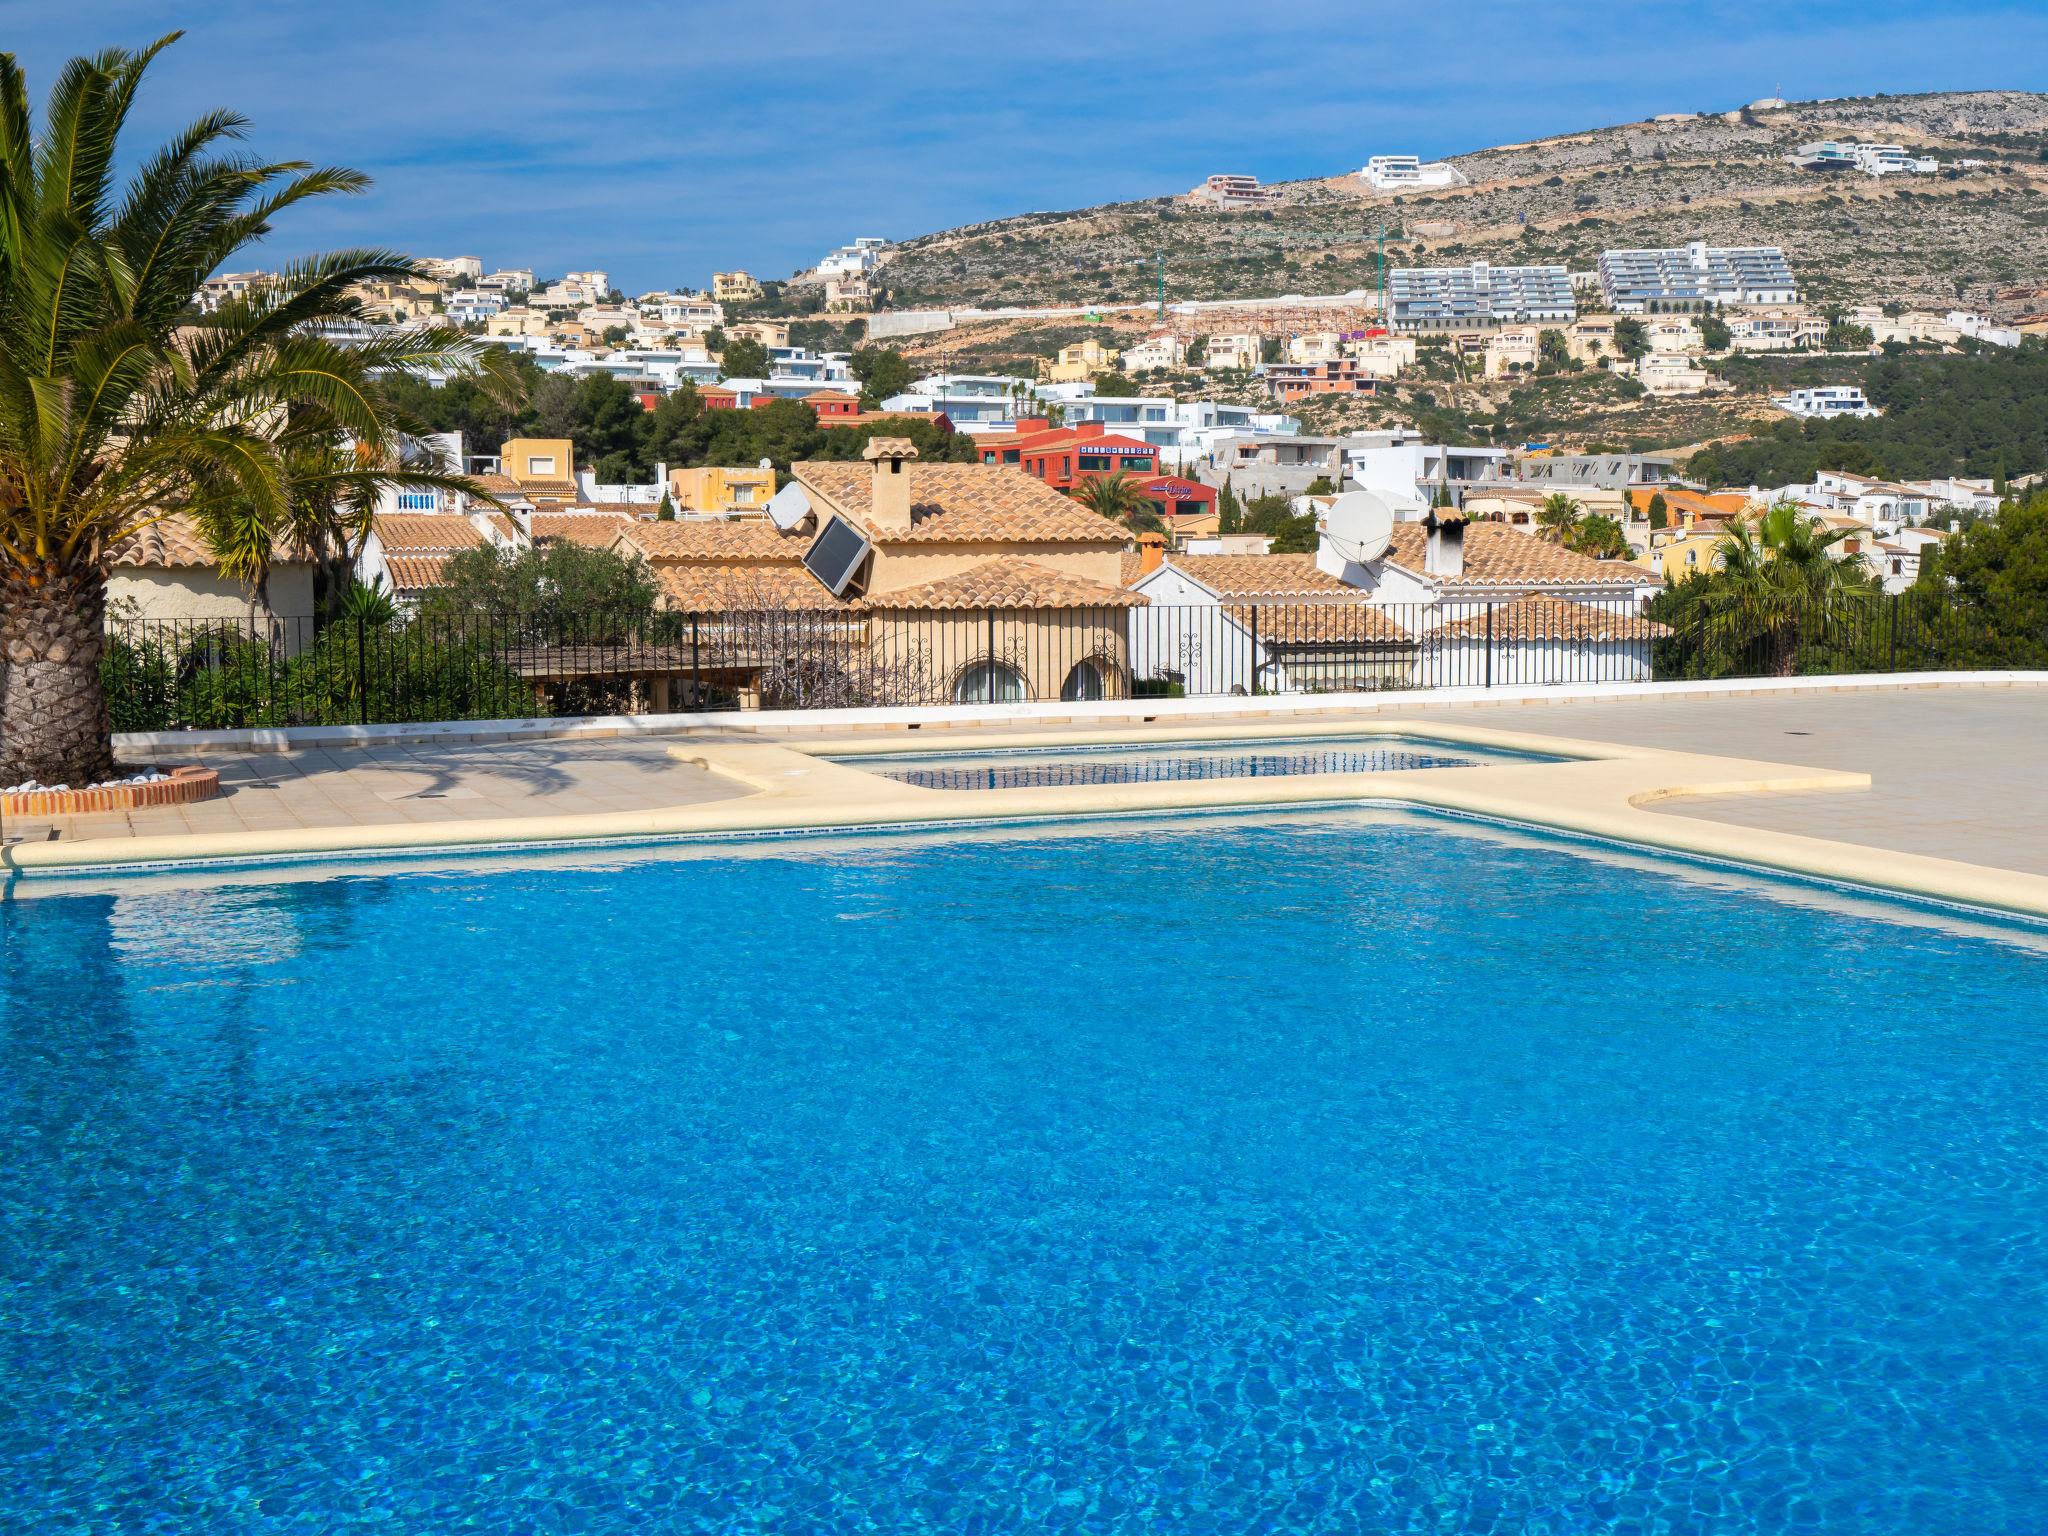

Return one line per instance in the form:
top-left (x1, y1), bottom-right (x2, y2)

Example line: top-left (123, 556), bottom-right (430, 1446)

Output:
top-left (140, 205), bottom-right (2048, 696)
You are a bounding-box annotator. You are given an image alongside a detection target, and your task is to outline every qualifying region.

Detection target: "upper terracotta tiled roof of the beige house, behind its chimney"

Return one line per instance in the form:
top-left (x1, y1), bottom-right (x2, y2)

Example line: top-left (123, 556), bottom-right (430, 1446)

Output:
top-left (791, 461), bottom-right (1124, 545)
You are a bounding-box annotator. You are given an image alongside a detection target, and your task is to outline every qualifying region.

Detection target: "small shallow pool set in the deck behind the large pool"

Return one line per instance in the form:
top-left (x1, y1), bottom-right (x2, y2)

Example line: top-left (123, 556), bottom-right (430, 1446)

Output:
top-left (831, 735), bottom-right (1561, 788)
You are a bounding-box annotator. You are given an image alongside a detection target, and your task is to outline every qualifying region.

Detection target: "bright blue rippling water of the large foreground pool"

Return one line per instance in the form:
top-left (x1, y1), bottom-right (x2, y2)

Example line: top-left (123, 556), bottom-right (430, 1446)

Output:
top-left (0, 813), bottom-right (2048, 1536)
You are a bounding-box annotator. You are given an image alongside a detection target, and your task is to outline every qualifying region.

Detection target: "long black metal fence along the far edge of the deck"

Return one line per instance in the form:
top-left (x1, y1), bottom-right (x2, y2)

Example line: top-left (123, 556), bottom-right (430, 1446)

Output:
top-left (102, 592), bottom-right (2048, 731)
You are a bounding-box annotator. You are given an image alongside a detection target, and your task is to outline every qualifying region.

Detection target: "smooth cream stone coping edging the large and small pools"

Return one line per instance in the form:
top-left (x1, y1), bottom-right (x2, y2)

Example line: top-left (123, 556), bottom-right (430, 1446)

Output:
top-left (12, 700), bottom-right (2048, 918)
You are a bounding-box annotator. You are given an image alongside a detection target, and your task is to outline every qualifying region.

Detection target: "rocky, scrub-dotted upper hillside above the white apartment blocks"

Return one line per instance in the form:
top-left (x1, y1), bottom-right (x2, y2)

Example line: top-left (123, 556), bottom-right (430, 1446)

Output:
top-left (883, 90), bottom-right (2048, 319)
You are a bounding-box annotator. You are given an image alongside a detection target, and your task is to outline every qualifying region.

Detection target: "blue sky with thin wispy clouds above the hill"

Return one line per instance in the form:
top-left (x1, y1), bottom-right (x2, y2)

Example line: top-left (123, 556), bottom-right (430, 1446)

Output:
top-left (0, 0), bottom-right (2048, 291)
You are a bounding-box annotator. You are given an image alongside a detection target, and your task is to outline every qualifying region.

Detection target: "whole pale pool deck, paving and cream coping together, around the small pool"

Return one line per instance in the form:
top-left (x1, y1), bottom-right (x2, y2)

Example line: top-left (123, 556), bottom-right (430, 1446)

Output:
top-left (6, 684), bottom-right (2048, 909)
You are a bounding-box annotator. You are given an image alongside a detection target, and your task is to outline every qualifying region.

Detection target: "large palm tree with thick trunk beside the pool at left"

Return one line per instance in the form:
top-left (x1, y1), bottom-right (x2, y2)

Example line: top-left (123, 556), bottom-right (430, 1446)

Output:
top-left (0, 33), bottom-right (505, 784)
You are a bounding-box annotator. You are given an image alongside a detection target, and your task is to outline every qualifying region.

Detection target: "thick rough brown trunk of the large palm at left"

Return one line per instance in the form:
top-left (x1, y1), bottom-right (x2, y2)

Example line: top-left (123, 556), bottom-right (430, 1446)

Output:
top-left (0, 561), bottom-right (115, 788)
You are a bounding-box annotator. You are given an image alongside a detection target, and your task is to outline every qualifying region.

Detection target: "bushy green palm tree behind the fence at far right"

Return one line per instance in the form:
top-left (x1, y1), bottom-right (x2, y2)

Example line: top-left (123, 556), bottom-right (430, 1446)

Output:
top-left (1704, 502), bottom-right (1878, 678)
